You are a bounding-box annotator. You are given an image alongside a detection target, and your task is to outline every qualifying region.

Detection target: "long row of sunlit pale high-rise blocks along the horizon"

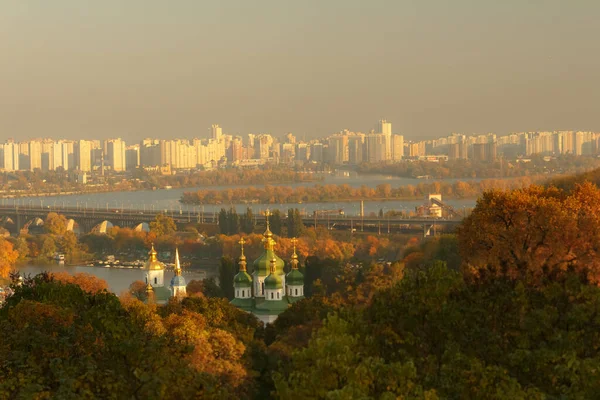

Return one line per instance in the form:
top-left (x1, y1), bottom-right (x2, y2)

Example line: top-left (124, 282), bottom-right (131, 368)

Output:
top-left (0, 119), bottom-right (600, 175)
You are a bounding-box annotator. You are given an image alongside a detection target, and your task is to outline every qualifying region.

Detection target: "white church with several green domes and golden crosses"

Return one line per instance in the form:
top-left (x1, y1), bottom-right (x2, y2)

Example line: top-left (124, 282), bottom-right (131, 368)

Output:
top-left (231, 215), bottom-right (304, 324)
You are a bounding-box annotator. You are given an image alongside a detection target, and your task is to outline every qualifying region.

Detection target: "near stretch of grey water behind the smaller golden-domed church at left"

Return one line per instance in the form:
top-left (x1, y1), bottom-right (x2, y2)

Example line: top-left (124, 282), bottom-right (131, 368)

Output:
top-left (16, 264), bottom-right (207, 294)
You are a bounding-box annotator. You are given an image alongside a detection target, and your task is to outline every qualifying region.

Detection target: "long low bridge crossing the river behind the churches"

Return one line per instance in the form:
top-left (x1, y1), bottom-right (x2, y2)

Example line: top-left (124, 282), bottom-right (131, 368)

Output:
top-left (0, 205), bottom-right (462, 236)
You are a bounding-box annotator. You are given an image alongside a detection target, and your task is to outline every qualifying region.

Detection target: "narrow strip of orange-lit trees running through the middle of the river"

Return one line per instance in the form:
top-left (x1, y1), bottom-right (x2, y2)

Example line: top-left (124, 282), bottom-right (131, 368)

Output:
top-left (180, 177), bottom-right (545, 204)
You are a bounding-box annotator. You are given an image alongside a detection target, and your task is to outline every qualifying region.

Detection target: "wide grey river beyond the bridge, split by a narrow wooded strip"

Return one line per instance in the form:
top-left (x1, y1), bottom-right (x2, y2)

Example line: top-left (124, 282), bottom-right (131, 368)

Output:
top-left (1, 173), bottom-right (475, 215)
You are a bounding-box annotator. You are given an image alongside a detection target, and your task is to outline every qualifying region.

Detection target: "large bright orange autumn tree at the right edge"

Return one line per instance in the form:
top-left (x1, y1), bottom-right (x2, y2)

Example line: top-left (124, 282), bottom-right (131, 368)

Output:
top-left (458, 183), bottom-right (600, 283)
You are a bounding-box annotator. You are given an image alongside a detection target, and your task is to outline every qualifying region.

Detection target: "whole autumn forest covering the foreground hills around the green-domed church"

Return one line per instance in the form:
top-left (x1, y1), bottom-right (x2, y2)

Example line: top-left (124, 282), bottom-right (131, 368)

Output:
top-left (0, 170), bottom-right (600, 399)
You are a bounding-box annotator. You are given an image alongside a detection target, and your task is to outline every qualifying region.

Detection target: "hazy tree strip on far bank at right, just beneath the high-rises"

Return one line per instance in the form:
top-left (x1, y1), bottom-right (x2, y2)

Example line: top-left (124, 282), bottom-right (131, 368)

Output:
top-left (357, 154), bottom-right (600, 179)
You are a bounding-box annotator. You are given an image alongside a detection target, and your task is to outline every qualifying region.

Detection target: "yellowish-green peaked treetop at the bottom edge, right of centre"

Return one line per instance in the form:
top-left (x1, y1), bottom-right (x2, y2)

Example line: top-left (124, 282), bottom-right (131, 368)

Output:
top-left (274, 316), bottom-right (437, 399)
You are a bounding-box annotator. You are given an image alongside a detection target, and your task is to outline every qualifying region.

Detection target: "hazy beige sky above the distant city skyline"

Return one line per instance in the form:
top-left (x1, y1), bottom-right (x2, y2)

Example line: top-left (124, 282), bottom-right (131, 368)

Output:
top-left (0, 0), bottom-right (600, 140)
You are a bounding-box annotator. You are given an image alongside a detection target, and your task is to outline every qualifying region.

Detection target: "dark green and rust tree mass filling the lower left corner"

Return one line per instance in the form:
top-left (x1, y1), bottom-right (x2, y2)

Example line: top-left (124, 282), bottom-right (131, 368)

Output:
top-left (0, 274), bottom-right (218, 399)
